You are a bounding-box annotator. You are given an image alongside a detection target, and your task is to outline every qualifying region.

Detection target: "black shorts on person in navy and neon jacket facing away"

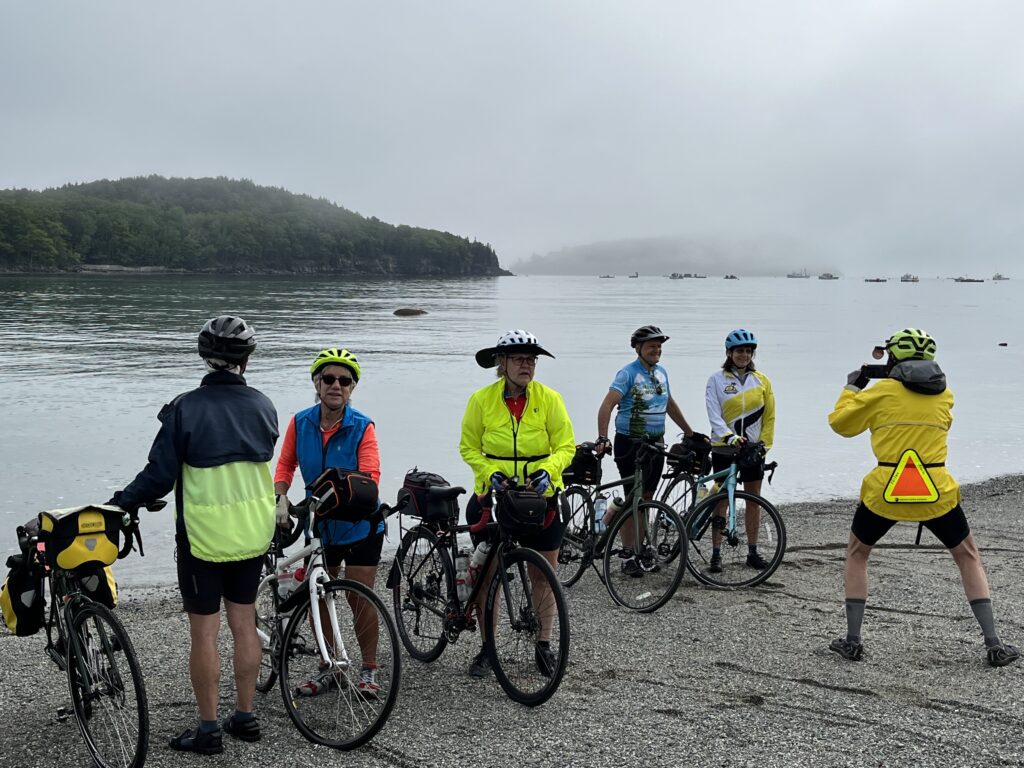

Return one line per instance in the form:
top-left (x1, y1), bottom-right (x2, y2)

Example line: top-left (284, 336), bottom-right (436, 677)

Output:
top-left (177, 538), bottom-right (263, 615)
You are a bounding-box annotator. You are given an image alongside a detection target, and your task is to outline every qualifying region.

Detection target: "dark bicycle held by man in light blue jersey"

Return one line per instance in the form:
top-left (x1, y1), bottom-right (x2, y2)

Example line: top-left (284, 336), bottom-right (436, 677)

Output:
top-left (558, 437), bottom-right (687, 613)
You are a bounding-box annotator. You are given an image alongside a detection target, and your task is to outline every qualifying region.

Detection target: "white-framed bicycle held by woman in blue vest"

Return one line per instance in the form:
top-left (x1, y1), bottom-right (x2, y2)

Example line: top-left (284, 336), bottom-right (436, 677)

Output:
top-left (256, 497), bottom-right (401, 750)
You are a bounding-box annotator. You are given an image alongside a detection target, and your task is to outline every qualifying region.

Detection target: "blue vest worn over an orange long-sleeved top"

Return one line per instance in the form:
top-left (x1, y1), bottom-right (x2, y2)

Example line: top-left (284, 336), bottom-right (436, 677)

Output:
top-left (295, 403), bottom-right (384, 545)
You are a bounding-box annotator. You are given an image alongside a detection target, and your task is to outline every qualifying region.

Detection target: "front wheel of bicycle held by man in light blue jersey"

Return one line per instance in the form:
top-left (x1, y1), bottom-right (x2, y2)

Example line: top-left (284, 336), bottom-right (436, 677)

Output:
top-left (604, 501), bottom-right (686, 613)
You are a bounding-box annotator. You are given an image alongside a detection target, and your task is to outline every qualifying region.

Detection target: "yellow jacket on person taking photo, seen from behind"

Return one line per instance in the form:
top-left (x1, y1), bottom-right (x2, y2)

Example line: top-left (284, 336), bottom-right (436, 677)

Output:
top-left (828, 372), bottom-right (961, 520)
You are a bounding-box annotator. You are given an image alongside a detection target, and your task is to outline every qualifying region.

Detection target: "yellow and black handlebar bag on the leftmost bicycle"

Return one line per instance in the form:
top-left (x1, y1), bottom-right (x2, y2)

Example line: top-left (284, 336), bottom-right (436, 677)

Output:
top-left (39, 504), bottom-right (124, 570)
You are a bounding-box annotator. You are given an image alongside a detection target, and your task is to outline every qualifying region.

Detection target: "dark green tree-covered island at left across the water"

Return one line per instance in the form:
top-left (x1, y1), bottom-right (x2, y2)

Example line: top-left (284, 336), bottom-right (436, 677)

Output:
top-left (0, 176), bottom-right (508, 278)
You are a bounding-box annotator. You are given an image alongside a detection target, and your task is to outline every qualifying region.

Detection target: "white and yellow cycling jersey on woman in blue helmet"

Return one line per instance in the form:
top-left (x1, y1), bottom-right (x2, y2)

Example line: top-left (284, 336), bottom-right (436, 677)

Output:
top-left (705, 371), bottom-right (775, 449)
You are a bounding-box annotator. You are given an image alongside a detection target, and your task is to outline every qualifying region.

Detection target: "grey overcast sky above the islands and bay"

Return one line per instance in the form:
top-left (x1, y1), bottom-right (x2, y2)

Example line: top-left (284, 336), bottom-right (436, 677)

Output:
top-left (0, 0), bottom-right (1024, 273)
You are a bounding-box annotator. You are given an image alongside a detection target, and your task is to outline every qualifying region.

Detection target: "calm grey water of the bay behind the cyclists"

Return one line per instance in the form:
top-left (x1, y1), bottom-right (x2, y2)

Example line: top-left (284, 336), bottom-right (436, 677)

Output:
top-left (0, 275), bottom-right (1024, 584)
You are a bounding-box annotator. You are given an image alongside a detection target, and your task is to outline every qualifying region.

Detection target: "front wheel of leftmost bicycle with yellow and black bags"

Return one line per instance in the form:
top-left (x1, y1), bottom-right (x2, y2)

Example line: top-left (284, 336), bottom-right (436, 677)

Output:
top-left (68, 601), bottom-right (150, 768)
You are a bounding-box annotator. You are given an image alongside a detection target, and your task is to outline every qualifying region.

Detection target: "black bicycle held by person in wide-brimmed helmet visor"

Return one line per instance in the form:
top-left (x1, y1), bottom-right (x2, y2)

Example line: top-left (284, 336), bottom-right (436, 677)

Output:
top-left (388, 485), bottom-right (569, 707)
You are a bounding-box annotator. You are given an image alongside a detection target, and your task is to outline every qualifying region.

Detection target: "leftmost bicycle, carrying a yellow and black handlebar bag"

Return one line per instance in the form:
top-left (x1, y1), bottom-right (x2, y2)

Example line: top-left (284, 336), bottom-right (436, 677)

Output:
top-left (17, 501), bottom-right (161, 768)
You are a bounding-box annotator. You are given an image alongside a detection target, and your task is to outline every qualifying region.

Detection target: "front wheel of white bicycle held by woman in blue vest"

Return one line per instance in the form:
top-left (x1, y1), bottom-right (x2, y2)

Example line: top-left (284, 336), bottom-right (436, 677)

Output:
top-left (280, 579), bottom-right (401, 750)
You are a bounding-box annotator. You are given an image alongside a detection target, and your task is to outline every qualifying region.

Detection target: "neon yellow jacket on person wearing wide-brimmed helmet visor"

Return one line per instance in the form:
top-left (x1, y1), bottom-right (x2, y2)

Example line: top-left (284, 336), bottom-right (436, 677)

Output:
top-left (459, 379), bottom-right (575, 496)
